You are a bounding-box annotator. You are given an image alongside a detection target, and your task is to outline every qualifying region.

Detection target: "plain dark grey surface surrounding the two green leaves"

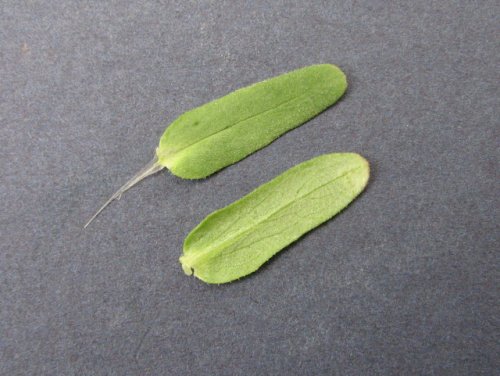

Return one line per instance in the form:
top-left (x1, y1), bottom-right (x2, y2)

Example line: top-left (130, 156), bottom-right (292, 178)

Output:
top-left (0, 0), bottom-right (500, 375)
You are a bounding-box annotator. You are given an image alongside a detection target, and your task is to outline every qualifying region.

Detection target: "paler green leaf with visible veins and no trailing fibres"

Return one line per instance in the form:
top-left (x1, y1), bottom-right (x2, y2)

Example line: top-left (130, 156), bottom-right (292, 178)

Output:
top-left (180, 153), bottom-right (369, 283)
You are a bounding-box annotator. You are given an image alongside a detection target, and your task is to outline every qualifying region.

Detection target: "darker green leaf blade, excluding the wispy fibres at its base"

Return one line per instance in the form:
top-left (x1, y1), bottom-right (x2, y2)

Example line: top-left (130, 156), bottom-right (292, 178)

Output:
top-left (156, 64), bottom-right (347, 179)
